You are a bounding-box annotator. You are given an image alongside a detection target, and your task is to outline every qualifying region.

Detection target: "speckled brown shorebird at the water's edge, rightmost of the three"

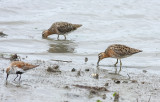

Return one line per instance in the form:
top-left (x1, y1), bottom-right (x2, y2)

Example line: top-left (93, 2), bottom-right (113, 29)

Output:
top-left (97, 44), bottom-right (142, 71)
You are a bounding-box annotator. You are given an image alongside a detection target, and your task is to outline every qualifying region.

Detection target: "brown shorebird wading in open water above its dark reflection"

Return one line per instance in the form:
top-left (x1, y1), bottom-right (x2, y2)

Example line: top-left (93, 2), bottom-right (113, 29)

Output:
top-left (42, 22), bottom-right (82, 39)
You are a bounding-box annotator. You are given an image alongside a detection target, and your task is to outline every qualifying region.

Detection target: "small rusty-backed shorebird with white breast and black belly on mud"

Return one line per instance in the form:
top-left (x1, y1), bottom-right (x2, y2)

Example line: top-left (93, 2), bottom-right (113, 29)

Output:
top-left (6, 61), bottom-right (39, 81)
